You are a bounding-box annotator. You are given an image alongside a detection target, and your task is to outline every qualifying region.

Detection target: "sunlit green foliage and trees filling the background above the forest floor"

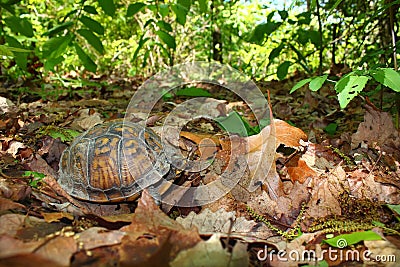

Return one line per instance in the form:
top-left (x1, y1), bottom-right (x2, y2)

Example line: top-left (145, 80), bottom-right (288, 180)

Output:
top-left (0, 0), bottom-right (400, 79)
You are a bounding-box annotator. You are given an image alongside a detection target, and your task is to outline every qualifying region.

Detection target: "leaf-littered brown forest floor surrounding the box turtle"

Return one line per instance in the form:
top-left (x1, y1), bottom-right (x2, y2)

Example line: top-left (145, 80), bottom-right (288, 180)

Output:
top-left (0, 73), bottom-right (400, 267)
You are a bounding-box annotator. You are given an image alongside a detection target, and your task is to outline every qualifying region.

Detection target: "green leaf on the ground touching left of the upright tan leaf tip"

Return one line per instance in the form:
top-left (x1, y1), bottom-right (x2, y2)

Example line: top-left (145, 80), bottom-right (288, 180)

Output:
top-left (215, 111), bottom-right (255, 136)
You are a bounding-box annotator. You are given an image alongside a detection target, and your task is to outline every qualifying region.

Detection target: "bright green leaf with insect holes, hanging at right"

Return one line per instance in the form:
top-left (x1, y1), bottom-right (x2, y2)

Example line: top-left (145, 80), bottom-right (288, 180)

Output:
top-left (335, 75), bottom-right (369, 108)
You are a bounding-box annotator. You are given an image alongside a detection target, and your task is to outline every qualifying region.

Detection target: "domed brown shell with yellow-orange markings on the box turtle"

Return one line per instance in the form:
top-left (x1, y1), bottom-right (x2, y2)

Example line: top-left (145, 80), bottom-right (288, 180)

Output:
top-left (58, 121), bottom-right (170, 202)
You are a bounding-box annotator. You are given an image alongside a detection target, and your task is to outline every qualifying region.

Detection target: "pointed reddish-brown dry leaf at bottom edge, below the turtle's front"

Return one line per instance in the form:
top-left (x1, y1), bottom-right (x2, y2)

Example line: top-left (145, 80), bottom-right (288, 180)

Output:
top-left (119, 190), bottom-right (201, 266)
